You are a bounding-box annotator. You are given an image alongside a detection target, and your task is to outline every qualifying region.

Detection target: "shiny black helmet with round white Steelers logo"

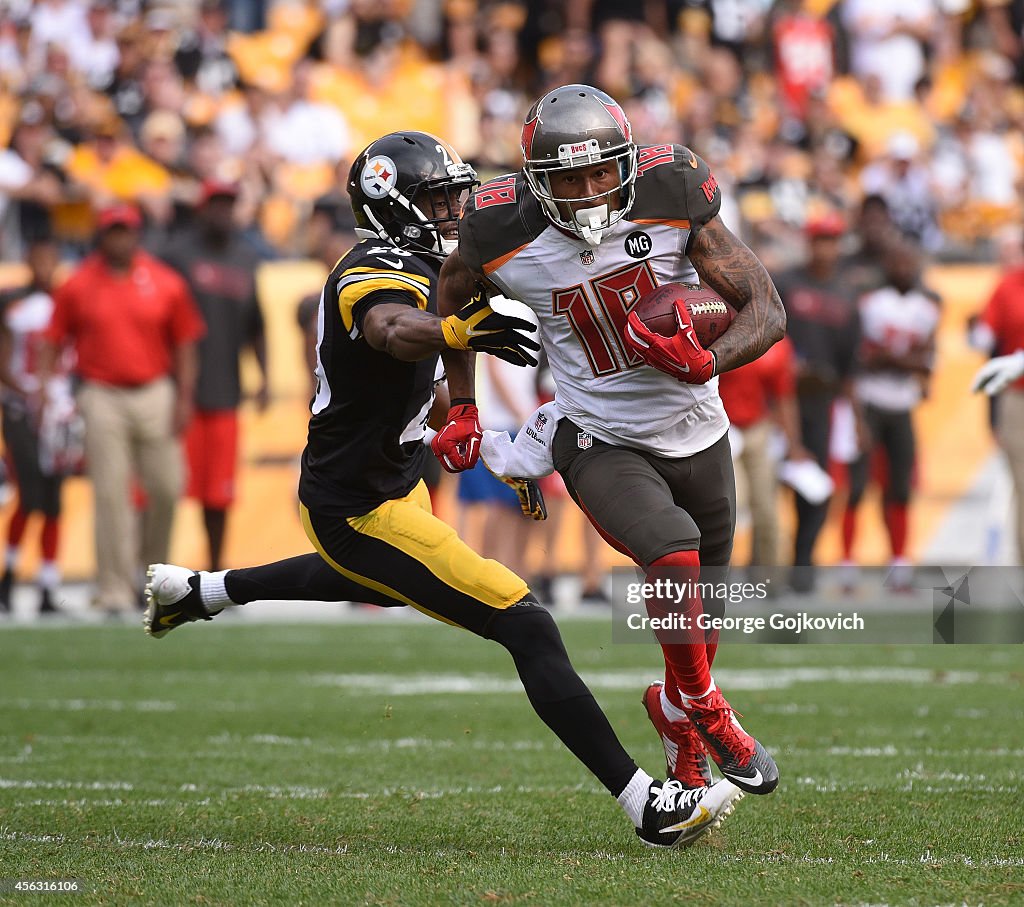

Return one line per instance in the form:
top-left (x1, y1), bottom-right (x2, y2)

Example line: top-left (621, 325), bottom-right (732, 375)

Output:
top-left (348, 132), bottom-right (479, 258)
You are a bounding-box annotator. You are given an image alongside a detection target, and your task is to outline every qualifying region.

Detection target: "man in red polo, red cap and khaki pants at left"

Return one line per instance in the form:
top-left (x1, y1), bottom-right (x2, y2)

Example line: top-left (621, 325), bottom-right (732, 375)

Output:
top-left (41, 205), bottom-right (205, 613)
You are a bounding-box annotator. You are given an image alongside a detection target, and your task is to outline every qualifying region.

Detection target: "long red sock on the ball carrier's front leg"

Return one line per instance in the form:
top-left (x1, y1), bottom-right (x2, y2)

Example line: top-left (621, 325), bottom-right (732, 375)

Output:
top-left (646, 551), bottom-right (711, 704)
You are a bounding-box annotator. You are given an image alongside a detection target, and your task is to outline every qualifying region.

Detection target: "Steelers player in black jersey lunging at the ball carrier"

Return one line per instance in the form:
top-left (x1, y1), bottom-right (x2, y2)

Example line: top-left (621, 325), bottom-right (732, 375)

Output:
top-left (144, 132), bottom-right (741, 847)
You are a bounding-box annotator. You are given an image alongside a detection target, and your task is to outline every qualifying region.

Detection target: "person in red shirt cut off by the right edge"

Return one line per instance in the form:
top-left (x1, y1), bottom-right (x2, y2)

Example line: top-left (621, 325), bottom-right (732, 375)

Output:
top-left (973, 241), bottom-right (1024, 564)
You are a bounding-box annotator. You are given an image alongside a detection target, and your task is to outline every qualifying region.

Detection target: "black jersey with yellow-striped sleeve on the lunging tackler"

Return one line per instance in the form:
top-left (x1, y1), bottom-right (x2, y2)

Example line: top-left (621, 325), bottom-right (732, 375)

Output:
top-left (299, 240), bottom-right (439, 516)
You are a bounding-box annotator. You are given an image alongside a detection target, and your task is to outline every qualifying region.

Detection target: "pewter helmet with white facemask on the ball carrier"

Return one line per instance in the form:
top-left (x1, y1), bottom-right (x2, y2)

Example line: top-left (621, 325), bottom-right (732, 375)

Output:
top-left (522, 85), bottom-right (637, 246)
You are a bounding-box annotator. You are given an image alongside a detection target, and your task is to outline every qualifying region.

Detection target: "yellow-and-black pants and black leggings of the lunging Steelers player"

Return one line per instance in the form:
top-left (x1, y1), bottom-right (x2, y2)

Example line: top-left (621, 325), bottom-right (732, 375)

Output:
top-left (224, 482), bottom-right (637, 796)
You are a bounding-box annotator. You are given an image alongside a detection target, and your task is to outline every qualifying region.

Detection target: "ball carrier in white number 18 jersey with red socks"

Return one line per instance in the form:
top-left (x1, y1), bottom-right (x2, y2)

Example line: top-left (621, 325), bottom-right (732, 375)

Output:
top-left (432, 85), bottom-right (785, 793)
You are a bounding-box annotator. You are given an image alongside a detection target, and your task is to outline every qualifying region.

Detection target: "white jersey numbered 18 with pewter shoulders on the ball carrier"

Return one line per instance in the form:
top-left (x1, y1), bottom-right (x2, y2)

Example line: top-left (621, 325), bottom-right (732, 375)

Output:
top-left (459, 152), bottom-right (729, 457)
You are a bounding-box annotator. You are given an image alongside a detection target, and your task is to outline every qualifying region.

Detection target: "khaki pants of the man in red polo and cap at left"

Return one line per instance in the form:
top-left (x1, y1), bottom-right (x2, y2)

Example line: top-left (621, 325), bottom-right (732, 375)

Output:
top-left (78, 378), bottom-right (184, 610)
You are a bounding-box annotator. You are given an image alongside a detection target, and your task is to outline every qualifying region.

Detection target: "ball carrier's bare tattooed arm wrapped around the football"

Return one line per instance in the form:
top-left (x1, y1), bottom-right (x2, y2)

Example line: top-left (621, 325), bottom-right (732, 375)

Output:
top-left (687, 217), bottom-right (785, 374)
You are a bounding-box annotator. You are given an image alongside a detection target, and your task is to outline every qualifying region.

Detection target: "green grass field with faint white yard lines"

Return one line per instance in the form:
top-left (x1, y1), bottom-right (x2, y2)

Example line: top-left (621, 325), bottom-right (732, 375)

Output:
top-left (0, 617), bottom-right (1024, 905)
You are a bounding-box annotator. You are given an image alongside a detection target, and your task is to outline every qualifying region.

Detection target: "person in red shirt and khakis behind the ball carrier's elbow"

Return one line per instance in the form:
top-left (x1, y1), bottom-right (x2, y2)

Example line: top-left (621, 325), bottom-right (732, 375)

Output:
top-left (718, 337), bottom-right (810, 567)
